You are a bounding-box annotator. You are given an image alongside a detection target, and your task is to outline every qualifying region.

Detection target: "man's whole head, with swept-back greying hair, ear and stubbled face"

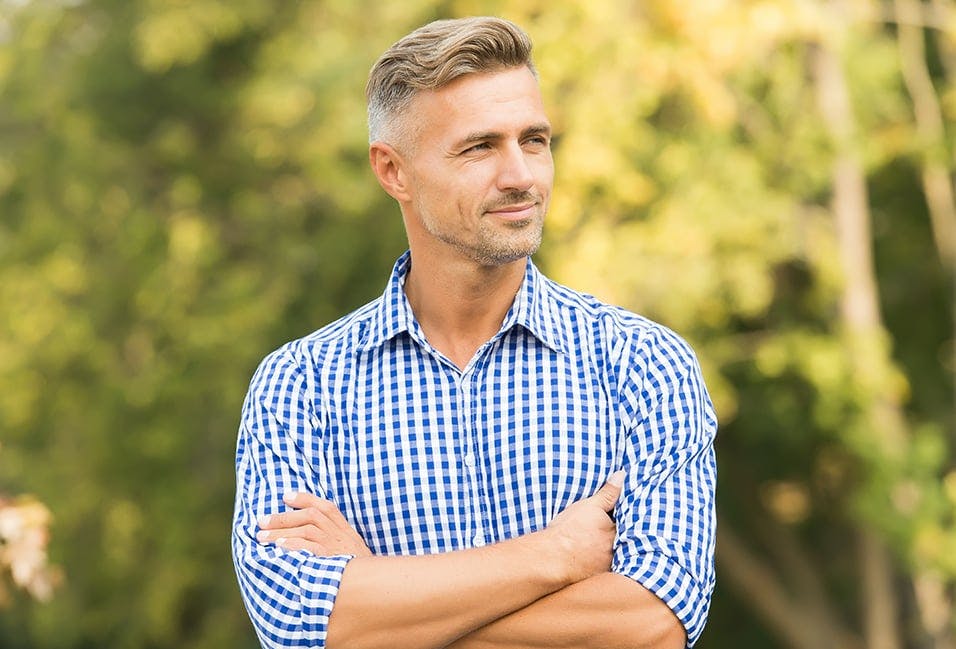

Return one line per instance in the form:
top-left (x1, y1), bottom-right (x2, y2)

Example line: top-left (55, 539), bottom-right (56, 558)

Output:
top-left (368, 18), bottom-right (554, 267)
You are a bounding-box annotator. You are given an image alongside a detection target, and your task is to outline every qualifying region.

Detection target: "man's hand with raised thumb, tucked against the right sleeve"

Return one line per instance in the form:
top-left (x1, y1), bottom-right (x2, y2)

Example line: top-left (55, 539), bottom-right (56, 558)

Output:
top-left (541, 471), bottom-right (624, 584)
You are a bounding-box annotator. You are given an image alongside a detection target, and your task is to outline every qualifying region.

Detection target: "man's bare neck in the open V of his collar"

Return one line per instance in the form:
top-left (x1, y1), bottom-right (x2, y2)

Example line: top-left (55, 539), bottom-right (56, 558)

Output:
top-left (405, 249), bottom-right (526, 369)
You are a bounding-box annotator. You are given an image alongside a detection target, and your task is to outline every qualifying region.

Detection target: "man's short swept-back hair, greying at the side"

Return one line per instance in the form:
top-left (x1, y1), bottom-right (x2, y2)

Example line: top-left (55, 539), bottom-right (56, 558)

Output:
top-left (365, 17), bottom-right (536, 145)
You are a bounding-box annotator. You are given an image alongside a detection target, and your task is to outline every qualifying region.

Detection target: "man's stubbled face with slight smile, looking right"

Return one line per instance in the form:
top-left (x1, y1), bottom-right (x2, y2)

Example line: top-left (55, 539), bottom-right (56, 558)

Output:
top-left (406, 67), bottom-right (554, 266)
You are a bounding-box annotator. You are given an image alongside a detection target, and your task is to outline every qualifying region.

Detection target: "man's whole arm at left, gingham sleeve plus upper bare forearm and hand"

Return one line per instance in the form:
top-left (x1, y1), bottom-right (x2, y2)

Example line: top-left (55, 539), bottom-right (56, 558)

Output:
top-left (233, 350), bottom-right (621, 648)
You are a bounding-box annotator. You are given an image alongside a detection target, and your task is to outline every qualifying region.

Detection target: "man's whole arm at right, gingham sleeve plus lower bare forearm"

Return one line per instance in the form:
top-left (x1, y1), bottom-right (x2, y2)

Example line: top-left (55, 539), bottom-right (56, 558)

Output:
top-left (451, 330), bottom-right (716, 649)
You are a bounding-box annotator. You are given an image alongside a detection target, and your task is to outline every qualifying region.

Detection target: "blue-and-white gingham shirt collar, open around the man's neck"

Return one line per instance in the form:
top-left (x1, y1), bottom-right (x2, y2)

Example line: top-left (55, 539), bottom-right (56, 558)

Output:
top-left (360, 251), bottom-right (568, 353)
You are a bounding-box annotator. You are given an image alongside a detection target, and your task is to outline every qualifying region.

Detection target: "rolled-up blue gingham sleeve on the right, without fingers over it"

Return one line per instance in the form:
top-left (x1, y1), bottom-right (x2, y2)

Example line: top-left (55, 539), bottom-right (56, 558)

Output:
top-left (612, 328), bottom-right (717, 647)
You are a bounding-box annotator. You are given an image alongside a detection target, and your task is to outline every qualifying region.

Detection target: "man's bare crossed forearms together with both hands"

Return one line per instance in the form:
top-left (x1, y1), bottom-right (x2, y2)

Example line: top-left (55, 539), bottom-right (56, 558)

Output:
top-left (258, 473), bottom-right (686, 649)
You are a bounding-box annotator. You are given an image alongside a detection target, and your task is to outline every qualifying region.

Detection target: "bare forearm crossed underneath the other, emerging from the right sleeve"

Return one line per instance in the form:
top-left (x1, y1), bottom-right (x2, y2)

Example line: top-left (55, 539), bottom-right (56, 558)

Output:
top-left (449, 573), bottom-right (686, 649)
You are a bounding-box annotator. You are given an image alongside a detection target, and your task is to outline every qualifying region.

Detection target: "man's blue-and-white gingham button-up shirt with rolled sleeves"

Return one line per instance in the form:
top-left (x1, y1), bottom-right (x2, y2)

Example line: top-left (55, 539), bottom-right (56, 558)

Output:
top-left (233, 253), bottom-right (716, 647)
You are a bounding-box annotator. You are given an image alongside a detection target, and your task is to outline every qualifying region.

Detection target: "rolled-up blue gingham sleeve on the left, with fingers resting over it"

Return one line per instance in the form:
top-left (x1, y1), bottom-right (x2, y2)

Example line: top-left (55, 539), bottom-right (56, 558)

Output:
top-left (232, 347), bottom-right (351, 648)
